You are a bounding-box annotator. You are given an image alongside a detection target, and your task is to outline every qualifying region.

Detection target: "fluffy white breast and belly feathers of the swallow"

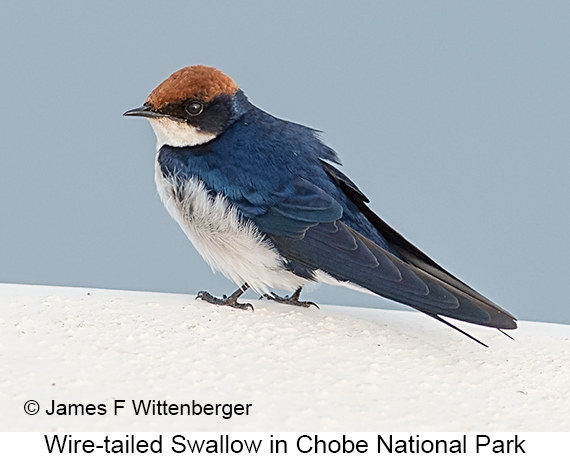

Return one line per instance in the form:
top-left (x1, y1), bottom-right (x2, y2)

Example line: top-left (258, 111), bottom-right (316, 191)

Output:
top-left (155, 156), bottom-right (307, 293)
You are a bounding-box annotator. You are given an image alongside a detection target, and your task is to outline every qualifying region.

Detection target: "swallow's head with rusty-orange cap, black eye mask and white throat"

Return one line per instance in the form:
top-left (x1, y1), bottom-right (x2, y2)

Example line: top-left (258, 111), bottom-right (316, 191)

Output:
top-left (124, 65), bottom-right (241, 148)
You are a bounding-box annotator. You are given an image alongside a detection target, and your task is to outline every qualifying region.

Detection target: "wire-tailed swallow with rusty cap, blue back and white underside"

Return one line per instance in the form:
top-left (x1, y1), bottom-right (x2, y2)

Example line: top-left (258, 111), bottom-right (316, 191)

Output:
top-left (124, 65), bottom-right (517, 344)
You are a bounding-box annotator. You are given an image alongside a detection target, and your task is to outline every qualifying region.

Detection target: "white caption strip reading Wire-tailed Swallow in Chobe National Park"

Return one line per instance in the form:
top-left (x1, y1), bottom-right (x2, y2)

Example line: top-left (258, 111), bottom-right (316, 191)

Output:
top-left (0, 432), bottom-right (570, 457)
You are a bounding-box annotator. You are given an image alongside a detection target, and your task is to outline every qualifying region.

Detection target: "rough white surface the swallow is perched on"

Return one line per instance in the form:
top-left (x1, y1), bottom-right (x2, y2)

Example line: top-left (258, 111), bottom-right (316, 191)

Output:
top-left (0, 284), bottom-right (570, 432)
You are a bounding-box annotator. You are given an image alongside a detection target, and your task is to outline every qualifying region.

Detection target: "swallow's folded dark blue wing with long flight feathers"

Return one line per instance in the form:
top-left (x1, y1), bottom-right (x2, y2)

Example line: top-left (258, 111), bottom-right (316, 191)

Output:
top-left (248, 164), bottom-right (516, 329)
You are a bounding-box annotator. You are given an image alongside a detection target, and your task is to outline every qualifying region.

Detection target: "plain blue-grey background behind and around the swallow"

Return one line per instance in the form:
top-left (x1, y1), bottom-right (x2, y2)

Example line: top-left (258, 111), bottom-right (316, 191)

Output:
top-left (0, 0), bottom-right (570, 323)
